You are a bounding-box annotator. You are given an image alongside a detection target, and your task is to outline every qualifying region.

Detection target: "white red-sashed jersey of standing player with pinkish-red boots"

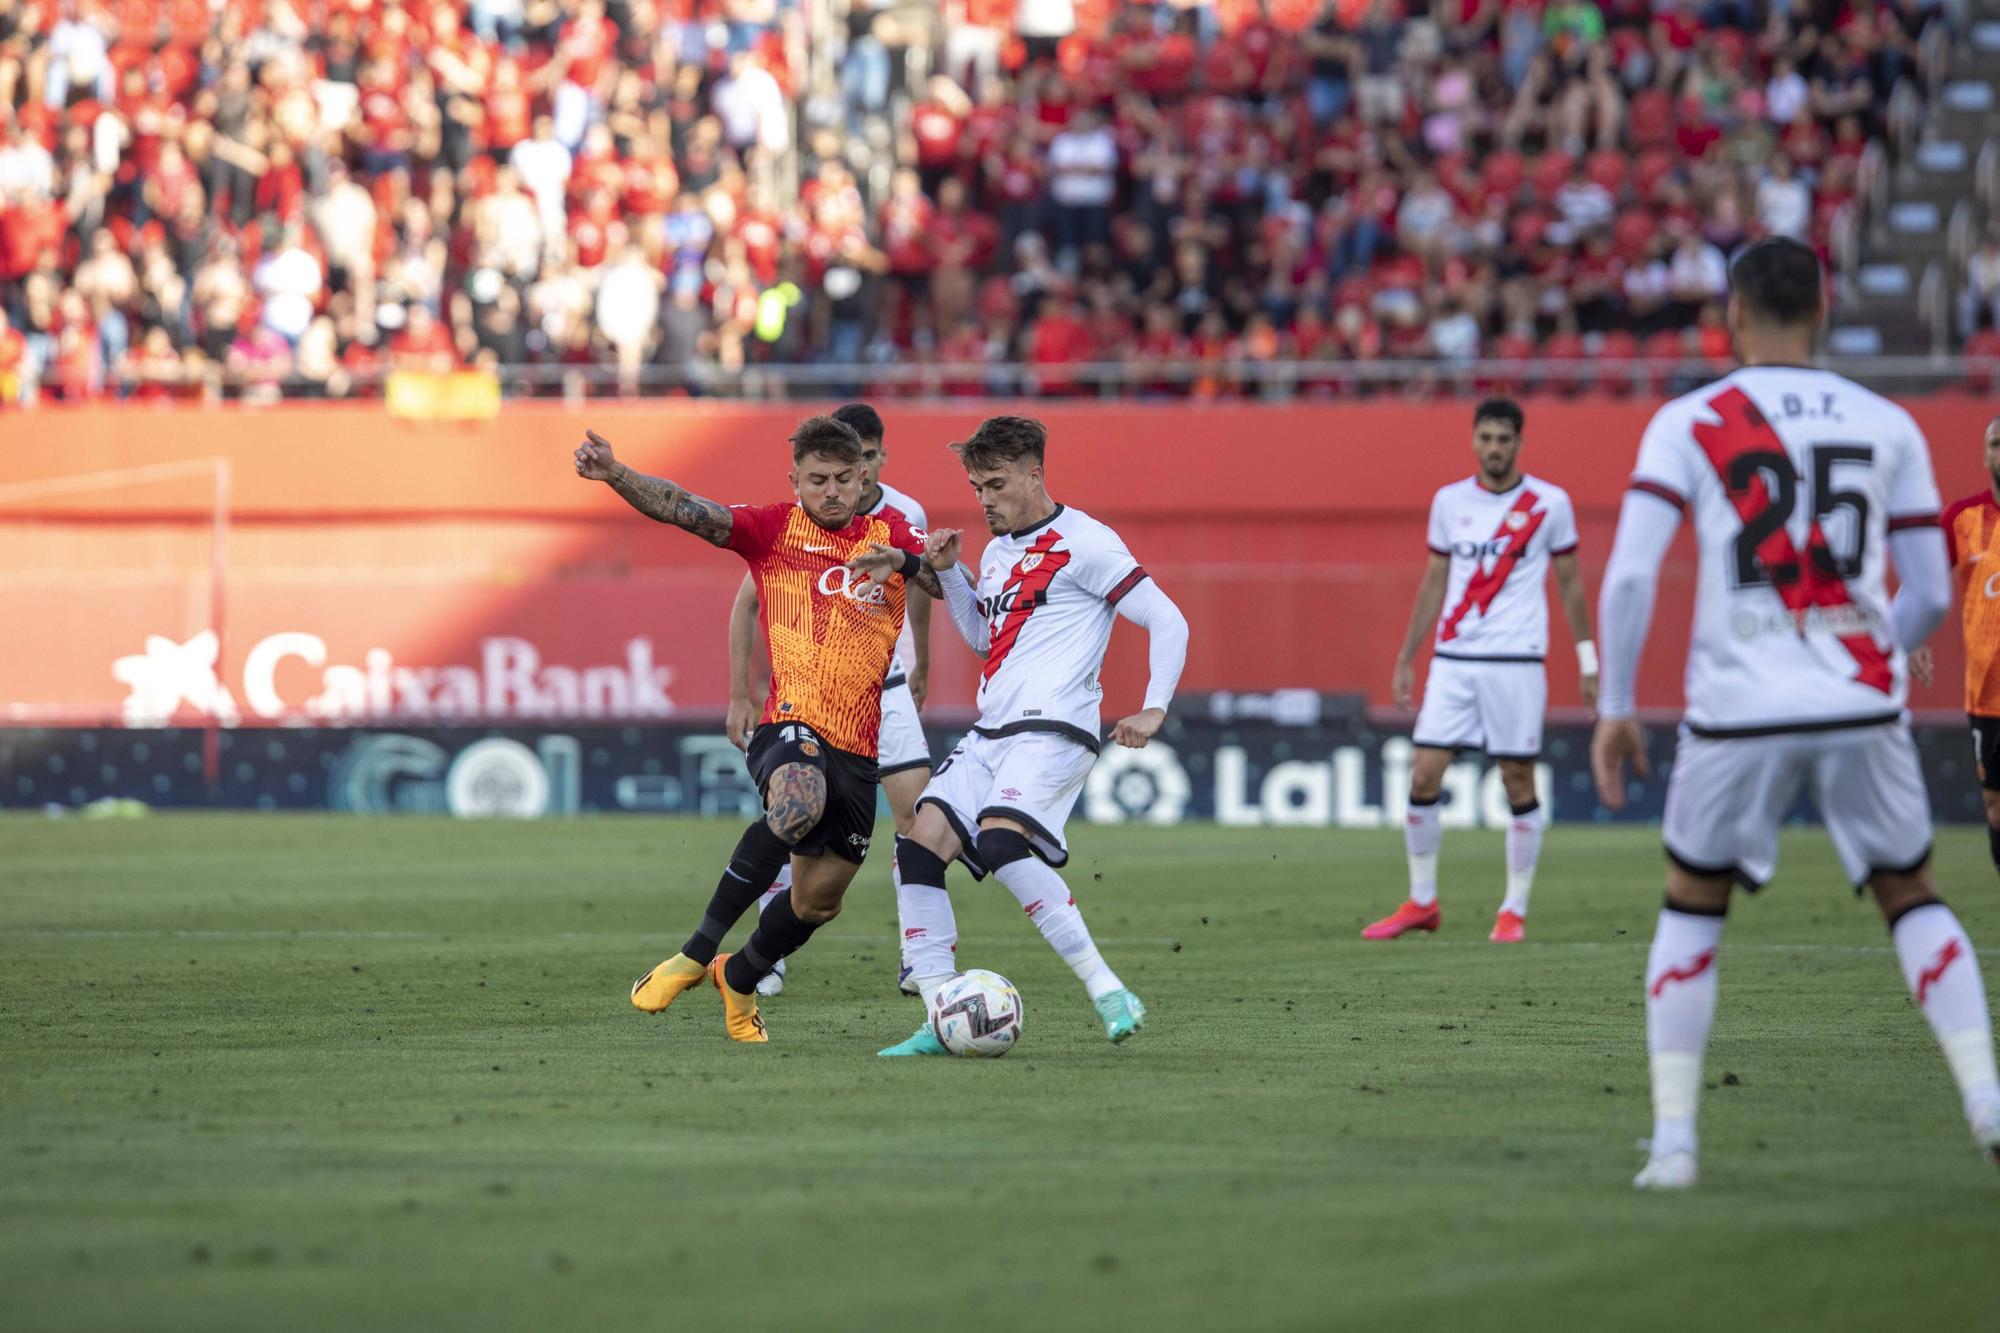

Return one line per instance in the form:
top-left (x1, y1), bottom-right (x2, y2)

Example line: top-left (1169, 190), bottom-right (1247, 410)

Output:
top-left (1430, 474), bottom-right (1576, 662)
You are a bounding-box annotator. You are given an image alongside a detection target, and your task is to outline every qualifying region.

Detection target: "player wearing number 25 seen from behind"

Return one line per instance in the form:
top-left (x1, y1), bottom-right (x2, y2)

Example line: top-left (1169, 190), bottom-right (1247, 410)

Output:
top-left (1590, 236), bottom-right (2000, 1189)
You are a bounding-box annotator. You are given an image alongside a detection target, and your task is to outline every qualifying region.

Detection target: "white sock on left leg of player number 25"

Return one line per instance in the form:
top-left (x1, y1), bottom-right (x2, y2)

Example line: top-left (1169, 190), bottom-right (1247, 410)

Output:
top-left (1646, 907), bottom-right (1724, 1157)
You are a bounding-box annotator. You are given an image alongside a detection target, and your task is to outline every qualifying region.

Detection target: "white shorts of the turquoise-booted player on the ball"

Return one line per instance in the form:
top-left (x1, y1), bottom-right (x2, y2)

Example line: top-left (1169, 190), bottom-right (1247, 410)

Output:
top-left (916, 731), bottom-right (1098, 879)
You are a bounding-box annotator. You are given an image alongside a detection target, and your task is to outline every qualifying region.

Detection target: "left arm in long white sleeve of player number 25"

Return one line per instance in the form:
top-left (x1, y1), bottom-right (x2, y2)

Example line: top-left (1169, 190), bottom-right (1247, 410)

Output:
top-left (1590, 490), bottom-right (1680, 811)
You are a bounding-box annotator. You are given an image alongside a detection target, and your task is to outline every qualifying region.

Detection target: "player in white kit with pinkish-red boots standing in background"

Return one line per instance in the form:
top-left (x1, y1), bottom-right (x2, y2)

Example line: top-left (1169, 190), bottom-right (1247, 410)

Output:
top-left (1362, 398), bottom-right (1598, 943)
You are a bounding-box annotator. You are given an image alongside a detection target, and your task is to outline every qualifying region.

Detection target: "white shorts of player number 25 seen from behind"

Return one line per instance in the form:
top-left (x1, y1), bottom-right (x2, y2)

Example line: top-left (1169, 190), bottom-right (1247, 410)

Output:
top-left (1662, 723), bottom-right (1930, 889)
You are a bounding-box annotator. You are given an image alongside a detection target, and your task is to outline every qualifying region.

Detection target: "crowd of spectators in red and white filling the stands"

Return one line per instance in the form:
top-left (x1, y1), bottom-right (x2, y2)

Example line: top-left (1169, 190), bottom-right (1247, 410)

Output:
top-left (0, 0), bottom-right (1952, 400)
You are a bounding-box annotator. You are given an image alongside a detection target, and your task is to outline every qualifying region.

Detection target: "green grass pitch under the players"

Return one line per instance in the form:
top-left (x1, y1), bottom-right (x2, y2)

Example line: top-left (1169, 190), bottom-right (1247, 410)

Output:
top-left (0, 817), bottom-right (2000, 1333)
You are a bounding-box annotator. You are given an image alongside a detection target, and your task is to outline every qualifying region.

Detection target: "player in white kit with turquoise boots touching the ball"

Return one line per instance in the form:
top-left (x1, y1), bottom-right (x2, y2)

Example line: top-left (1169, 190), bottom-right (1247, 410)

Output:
top-left (848, 416), bottom-right (1188, 1055)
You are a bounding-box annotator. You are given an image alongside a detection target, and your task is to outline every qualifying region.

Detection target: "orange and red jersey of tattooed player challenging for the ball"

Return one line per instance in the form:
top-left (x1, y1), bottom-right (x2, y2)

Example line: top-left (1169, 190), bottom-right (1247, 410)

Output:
top-left (730, 504), bottom-right (924, 759)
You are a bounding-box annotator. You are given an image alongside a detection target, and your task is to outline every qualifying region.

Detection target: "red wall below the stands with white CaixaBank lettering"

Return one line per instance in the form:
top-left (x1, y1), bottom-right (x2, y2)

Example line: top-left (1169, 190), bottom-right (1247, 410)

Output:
top-left (0, 398), bottom-right (1990, 725)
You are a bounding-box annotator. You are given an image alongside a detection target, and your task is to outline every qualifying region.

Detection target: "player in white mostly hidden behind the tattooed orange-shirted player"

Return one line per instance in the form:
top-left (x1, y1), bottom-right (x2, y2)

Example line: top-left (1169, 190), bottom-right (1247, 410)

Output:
top-left (724, 402), bottom-right (930, 995)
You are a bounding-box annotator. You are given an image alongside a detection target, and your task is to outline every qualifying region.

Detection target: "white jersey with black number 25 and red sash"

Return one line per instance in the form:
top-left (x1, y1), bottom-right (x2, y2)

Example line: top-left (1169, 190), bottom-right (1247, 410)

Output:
top-left (1632, 366), bottom-right (1938, 737)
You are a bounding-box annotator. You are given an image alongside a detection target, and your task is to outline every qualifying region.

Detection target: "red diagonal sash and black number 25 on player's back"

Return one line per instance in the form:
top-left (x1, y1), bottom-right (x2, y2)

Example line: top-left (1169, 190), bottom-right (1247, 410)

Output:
top-left (1694, 386), bottom-right (1894, 695)
